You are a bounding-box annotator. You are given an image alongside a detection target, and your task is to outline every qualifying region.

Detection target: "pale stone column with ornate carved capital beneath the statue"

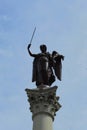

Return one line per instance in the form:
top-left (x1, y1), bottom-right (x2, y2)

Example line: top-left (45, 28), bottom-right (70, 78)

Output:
top-left (25, 86), bottom-right (61, 130)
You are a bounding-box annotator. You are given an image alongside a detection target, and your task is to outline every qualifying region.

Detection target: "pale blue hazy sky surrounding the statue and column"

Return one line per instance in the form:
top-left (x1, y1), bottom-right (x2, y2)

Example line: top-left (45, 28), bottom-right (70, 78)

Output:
top-left (0, 0), bottom-right (87, 130)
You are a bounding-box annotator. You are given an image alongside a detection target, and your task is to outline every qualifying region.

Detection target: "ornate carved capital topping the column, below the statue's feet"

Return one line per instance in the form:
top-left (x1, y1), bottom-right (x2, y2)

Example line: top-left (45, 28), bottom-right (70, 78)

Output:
top-left (25, 86), bottom-right (61, 120)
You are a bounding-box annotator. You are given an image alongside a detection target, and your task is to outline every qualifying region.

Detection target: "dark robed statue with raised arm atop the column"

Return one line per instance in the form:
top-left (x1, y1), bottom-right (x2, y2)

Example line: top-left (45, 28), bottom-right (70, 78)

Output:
top-left (27, 44), bottom-right (64, 87)
